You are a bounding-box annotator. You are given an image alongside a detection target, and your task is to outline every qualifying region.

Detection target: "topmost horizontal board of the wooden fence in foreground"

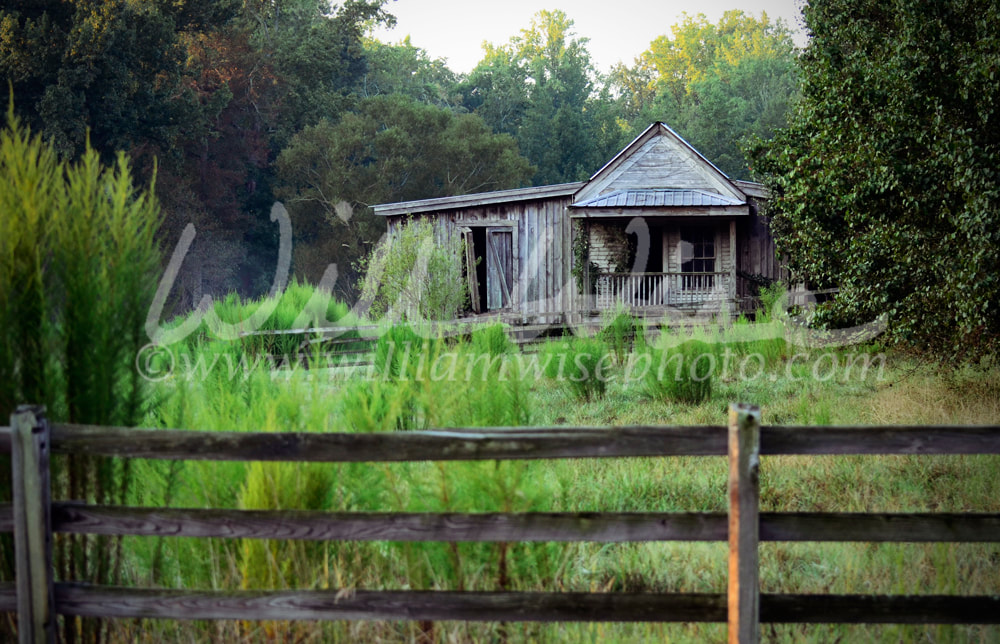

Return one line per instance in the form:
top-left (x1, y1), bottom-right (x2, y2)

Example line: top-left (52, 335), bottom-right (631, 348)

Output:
top-left (0, 424), bottom-right (1000, 462)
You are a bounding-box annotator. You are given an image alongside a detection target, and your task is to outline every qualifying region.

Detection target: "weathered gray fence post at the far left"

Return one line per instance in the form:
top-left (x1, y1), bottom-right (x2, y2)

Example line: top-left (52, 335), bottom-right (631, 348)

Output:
top-left (10, 405), bottom-right (55, 644)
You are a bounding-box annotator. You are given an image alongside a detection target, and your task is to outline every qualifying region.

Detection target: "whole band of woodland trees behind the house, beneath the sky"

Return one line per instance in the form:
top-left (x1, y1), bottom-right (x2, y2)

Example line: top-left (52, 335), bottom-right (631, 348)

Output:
top-left (0, 0), bottom-right (795, 314)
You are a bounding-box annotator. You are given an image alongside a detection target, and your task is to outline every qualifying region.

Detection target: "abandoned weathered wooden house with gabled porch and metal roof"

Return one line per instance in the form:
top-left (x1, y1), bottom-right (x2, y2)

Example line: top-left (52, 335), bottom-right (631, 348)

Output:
top-left (374, 123), bottom-right (781, 324)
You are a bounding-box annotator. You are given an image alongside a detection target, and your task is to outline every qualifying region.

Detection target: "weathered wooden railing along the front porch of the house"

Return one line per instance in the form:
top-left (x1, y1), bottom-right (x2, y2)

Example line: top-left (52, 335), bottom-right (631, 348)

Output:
top-left (596, 272), bottom-right (730, 309)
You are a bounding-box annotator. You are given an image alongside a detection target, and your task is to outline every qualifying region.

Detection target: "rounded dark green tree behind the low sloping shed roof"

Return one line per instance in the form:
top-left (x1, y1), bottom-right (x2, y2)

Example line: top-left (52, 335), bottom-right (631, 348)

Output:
top-left (277, 94), bottom-right (532, 293)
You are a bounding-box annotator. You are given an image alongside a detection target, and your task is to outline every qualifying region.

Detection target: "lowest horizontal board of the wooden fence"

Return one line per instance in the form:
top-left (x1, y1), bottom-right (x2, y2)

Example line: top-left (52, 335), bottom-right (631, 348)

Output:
top-left (0, 583), bottom-right (1000, 624)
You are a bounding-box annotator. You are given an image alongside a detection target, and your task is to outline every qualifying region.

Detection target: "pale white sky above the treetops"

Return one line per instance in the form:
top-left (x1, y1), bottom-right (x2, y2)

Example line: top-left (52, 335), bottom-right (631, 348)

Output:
top-left (374, 0), bottom-right (805, 72)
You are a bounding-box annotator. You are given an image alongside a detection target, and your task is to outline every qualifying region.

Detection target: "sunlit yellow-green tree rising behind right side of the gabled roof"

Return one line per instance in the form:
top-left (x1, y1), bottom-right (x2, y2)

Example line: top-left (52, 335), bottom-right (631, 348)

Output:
top-left (609, 11), bottom-right (798, 178)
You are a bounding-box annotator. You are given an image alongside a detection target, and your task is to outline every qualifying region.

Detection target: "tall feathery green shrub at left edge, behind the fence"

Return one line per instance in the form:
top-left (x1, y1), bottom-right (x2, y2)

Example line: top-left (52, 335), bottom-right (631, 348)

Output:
top-left (0, 106), bottom-right (160, 641)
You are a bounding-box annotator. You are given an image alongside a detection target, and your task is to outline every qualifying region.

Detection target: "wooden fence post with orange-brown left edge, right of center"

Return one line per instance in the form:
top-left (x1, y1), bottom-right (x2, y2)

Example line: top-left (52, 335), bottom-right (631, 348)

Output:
top-left (729, 403), bottom-right (760, 644)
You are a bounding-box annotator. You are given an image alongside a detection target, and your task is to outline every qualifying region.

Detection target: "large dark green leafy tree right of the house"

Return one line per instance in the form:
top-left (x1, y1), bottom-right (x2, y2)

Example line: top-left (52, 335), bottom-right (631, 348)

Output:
top-left (754, 0), bottom-right (1000, 356)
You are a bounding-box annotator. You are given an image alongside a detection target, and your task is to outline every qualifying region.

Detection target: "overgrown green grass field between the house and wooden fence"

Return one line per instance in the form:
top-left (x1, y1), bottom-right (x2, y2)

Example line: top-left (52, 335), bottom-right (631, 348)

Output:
top-left (103, 294), bottom-right (1000, 642)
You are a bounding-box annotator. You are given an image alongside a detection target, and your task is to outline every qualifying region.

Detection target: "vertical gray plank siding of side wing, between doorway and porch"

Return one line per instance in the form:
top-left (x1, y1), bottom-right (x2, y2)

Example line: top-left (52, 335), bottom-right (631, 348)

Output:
top-left (387, 196), bottom-right (576, 322)
